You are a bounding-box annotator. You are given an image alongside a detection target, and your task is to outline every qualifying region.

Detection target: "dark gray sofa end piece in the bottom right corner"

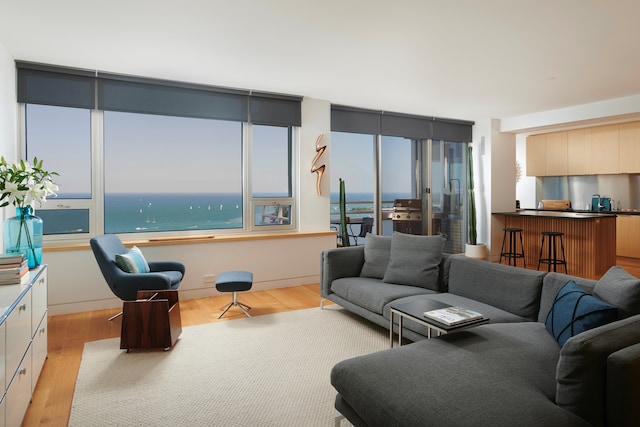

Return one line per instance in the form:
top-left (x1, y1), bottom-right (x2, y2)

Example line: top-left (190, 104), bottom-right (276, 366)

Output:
top-left (606, 343), bottom-right (640, 426)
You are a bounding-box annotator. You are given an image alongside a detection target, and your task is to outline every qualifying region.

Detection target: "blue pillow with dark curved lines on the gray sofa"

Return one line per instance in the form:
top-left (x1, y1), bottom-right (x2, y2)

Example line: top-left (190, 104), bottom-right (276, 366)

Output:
top-left (545, 280), bottom-right (618, 347)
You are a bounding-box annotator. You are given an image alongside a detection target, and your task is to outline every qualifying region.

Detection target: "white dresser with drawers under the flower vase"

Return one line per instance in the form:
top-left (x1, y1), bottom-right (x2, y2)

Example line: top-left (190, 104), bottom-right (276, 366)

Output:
top-left (0, 265), bottom-right (47, 427)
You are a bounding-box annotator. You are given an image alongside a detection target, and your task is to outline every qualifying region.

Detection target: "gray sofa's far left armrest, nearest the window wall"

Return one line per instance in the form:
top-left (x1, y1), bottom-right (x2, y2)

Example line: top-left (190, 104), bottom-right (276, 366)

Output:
top-left (320, 246), bottom-right (364, 298)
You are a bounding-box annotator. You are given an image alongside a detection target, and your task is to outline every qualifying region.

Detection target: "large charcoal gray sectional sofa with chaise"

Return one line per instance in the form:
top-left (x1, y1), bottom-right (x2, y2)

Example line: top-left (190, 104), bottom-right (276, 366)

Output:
top-left (321, 233), bottom-right (640, 427)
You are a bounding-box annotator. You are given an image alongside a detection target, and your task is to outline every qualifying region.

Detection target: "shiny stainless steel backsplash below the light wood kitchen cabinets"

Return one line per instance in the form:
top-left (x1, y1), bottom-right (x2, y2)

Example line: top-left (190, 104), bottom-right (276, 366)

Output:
top-left (536, 174), bottom-right (640, 210)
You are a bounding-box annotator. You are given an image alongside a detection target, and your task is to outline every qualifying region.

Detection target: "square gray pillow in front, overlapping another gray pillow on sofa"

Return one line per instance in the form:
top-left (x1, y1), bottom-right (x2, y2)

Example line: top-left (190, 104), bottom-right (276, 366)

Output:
top-left (382, 231), bottom-right (446, 291)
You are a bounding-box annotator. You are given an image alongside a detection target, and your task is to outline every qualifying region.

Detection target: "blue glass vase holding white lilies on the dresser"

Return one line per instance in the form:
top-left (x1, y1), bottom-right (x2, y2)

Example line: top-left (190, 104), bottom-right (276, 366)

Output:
top-left (4, 206), bottom-right (42, 268)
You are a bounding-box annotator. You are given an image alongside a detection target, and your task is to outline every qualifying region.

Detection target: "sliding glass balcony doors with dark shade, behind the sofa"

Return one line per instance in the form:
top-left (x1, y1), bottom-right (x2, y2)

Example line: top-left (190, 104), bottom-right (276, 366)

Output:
top-left (331, 105), bottom-right (473, 252)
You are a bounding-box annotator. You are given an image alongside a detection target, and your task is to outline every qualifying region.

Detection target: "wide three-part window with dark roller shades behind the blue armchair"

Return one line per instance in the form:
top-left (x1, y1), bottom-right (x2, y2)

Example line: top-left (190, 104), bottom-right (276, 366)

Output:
top-left (16, 62), bottom-right (301, 241)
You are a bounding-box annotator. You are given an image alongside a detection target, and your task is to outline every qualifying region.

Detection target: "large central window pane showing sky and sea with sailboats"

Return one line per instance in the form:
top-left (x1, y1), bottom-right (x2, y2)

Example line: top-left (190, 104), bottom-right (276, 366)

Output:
top-left (104, 111), bottom-right (244, 233)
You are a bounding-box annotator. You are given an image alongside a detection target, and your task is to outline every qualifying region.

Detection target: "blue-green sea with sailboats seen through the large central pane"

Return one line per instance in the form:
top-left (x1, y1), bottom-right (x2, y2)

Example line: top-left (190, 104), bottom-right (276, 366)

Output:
top-left (104, 193), bottom-right (242, 233)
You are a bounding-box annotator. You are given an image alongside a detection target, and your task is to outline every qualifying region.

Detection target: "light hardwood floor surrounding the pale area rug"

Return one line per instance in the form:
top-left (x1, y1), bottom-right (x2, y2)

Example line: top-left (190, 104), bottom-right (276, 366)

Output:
top-left (22, 284), bottom-right (330, 427)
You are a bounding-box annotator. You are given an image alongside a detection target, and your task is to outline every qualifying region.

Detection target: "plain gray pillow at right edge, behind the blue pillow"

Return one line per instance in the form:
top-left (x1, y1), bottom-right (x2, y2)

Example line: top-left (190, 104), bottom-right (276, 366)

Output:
top-left (593, 267), bottom-right (640, 318)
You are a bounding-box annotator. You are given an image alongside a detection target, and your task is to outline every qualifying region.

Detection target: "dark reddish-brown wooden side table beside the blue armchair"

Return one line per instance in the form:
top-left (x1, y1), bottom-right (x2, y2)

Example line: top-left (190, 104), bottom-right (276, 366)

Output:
top-left (120, 290), bottom-right (182, 352)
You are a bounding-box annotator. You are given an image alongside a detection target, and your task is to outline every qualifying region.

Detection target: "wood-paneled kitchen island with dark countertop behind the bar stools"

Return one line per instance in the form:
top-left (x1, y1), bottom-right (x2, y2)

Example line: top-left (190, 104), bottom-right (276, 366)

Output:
top-left (493, 209), bottom-right (616, 279)
